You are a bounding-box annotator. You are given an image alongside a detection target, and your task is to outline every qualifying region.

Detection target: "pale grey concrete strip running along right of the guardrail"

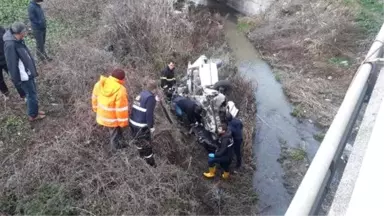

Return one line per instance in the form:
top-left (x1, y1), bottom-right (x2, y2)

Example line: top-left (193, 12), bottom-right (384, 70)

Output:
top-left (328, 69), bottom-right (384, 216)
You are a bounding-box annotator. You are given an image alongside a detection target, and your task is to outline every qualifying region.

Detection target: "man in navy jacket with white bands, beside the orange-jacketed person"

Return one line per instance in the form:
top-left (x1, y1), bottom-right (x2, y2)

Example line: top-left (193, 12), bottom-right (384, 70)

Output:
top-left (129, 81), bottom-right (157, 167)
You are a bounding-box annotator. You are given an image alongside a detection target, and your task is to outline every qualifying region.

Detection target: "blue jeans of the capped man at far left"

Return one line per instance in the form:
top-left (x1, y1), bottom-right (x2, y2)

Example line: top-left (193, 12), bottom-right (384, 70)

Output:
top-left (21, 79), bottom-right (39, 118)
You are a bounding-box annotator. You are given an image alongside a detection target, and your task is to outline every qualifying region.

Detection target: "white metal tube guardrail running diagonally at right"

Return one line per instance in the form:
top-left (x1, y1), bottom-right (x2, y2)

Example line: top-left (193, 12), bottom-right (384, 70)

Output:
top-left (285, 25), bottom-right (384, 216)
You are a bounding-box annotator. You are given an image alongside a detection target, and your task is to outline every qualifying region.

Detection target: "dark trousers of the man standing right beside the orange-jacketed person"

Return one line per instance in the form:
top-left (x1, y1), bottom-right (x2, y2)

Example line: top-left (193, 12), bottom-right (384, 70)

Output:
top-left (130, 126), bottom-right (156, 167)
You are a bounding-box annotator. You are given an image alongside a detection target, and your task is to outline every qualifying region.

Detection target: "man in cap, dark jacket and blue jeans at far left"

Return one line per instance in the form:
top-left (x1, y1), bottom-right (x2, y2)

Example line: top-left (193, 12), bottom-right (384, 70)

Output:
top-left (3, 22), bottom-right (45, 121)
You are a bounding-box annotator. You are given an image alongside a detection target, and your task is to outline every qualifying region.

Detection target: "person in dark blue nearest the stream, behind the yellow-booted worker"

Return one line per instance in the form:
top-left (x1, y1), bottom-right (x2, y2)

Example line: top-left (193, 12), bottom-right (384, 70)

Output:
top-left (227, 113), bottom-right (243, 168)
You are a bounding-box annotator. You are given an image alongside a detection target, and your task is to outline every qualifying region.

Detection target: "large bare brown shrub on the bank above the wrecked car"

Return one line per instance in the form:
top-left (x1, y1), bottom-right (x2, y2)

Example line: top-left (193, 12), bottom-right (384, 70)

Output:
top-left (103, 0), bottom-right (223, 70)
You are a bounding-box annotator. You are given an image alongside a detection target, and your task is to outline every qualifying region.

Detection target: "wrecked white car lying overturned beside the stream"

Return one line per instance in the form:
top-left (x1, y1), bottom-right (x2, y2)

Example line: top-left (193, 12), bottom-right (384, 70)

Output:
top-left (170, 55), bottom-right (239, 150)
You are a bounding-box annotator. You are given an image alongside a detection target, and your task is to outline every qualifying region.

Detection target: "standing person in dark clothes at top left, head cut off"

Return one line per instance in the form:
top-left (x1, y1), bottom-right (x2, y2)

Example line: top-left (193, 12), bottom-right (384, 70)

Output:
top-left (28, 0), bottom-right (51, 61)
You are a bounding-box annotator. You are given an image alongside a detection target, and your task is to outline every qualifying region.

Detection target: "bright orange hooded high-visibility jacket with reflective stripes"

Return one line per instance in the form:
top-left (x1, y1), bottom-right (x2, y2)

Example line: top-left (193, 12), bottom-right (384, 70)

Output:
top-left (92, 76), bottom-right (129, 127)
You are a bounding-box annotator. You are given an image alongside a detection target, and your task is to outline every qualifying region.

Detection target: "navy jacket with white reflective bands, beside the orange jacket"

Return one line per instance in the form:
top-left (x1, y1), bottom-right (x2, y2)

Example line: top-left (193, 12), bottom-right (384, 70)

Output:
top-left (129, 90), bottom-right (156, 128)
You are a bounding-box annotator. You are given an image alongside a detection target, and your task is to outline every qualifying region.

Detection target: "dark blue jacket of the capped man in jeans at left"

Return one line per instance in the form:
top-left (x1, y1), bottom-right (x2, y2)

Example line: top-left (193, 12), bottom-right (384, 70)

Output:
top-left (3, 30), bottom-right (38, 85)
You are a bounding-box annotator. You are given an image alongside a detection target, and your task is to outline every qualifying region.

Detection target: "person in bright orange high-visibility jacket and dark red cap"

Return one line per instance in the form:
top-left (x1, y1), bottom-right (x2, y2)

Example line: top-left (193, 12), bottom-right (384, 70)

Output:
top-left (92, 69), bottom-right (129, 151)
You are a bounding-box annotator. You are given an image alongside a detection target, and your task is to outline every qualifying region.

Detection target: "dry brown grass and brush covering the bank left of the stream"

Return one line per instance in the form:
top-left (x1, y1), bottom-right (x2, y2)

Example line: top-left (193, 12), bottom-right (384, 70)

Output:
top-left (0, 0), bottom-right (257, 216)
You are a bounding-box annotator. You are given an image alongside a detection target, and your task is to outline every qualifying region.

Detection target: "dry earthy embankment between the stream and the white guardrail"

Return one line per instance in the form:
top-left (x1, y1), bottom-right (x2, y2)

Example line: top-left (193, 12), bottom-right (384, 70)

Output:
top-left (244, 0), bottom-right (376, 128)
